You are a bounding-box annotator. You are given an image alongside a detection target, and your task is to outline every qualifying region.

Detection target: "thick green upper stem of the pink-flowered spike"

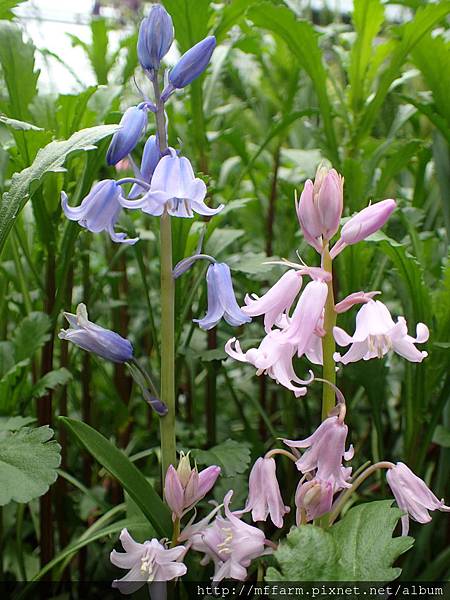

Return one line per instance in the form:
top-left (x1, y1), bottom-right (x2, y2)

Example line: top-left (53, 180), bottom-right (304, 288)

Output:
top-left (322, 245), bottom-right (336, 420)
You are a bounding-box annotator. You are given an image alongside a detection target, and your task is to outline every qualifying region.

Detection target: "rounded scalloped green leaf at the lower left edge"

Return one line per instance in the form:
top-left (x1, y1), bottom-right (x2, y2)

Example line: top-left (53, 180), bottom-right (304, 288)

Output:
top-left (0, 426), bottom-right (61, 506)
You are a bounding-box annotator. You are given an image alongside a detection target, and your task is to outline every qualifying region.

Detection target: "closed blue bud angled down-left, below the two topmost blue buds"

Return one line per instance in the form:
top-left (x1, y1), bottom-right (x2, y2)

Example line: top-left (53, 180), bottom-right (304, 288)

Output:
top-left (106, 102), bottom-right (148, 165)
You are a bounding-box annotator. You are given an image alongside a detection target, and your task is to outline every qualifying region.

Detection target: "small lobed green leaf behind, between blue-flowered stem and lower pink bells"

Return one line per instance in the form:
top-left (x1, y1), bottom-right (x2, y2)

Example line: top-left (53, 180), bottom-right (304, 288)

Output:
top-left (192, 440), bottom-right (250, 477)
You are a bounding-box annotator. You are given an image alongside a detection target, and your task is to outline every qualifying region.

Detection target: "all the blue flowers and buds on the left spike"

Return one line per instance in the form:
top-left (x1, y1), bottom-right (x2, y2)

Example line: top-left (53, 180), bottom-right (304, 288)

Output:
top-left (60, 4), bottom-right (251, 380)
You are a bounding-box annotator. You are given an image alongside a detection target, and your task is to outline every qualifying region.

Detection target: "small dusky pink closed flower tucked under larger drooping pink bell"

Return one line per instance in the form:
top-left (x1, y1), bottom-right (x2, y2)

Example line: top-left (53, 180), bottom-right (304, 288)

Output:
top-left (295, 478), bottom-right (334, 526)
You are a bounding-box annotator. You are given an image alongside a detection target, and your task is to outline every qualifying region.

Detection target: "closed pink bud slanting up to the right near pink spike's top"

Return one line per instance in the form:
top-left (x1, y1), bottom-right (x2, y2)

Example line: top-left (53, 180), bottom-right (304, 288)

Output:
top-left (330, 199), bottom-right (397, 258)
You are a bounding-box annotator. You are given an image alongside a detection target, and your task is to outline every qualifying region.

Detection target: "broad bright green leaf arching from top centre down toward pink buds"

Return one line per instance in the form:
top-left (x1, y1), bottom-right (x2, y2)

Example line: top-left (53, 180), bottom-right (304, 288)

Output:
top-left (248, 2), bottom-right (338, 163)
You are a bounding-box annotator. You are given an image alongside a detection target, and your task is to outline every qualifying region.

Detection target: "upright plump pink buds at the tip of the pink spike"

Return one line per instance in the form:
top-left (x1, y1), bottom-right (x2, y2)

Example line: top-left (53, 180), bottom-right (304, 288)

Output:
top-left (296, 166), bottom-right (344, 252)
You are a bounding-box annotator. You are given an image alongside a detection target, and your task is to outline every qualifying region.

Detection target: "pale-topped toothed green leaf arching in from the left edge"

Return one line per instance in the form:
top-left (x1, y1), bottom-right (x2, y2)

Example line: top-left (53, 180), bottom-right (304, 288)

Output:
top-left (0, 125), bottom-right (118, 253)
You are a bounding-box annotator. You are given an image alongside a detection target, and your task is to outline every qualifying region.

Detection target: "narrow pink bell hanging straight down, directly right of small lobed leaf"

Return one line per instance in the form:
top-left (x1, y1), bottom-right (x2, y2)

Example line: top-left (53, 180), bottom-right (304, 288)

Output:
top-left (244, 457), bottom-right (289, 528)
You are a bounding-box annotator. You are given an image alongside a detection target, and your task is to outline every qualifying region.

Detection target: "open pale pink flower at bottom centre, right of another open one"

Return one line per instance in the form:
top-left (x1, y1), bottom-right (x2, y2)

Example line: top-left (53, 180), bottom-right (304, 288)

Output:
top-left (180, 490), bottom-right (267, 581)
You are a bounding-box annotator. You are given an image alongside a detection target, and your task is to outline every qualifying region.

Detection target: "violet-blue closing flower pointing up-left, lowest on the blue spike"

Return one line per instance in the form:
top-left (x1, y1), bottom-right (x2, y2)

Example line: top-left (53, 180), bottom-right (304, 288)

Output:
top-left (58, 304), bottom-right (133, 363)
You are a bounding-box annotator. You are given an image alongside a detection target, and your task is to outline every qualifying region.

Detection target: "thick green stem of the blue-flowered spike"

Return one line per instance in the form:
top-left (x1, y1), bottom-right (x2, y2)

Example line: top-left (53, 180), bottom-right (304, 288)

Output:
top-left (153, 76), bottom-right (176, 483)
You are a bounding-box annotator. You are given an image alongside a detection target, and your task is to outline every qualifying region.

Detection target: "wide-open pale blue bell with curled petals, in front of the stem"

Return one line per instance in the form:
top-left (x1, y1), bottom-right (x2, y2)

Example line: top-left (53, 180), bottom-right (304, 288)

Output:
top-left (121, 148), bottom-right (223, 218)
